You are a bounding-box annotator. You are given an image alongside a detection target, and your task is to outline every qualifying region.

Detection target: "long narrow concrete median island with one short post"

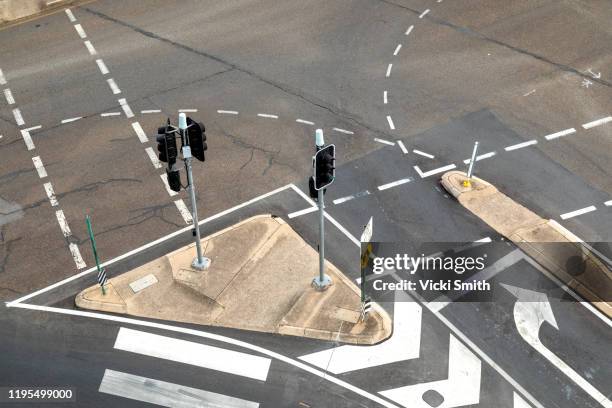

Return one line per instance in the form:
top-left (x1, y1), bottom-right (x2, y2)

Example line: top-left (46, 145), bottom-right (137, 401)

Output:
top-left (440, 171), bottom-right (612, 317)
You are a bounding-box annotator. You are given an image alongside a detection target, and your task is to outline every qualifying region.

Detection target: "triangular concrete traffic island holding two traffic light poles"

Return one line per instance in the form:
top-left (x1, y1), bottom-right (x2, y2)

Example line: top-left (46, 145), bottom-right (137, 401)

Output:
top-left (76, 215), bottom-right (392, 344)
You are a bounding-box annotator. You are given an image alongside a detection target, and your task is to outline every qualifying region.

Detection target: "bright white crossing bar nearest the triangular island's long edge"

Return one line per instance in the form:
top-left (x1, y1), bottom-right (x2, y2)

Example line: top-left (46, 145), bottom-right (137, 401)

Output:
top-left (114, 327), bottom-right (272, 381)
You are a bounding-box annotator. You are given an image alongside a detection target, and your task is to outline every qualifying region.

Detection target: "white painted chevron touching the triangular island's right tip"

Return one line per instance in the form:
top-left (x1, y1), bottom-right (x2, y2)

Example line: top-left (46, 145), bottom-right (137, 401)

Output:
top-left (300, 301), bottom-right (423, 374)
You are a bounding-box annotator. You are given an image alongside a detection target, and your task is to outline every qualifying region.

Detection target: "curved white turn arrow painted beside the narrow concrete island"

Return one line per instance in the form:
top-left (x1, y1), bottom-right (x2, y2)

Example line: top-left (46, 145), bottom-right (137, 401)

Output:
top-left (501, 283), bottom-right (612, 408)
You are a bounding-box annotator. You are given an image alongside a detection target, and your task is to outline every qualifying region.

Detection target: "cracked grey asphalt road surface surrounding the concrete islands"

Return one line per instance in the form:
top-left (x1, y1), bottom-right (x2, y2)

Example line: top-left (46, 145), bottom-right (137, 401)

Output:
top-left (0, 0), bottom-right (612, 408)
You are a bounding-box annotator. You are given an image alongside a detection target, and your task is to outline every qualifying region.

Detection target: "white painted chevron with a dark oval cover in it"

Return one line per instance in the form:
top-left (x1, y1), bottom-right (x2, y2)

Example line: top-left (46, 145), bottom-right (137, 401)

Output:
top-left (380, 334), bottom-right (481, 408)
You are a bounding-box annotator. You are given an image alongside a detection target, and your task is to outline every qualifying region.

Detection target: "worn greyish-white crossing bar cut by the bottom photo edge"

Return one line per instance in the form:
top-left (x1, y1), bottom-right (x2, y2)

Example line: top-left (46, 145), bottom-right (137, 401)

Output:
top-left (98, 369), bottom-right (259, 408)
